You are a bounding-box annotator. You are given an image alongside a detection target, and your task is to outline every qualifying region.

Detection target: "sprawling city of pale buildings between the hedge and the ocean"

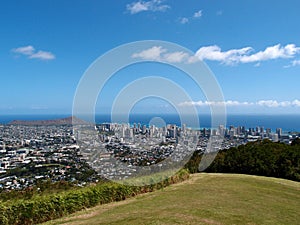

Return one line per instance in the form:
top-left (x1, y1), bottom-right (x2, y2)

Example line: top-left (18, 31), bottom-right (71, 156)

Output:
top-left (0, 119), bottom-right (299, 189)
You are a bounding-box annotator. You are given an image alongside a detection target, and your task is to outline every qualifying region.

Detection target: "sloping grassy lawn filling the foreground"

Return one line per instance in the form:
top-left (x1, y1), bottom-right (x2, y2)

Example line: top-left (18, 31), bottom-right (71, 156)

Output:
top-left (45, 173), bottom-right (300, 225)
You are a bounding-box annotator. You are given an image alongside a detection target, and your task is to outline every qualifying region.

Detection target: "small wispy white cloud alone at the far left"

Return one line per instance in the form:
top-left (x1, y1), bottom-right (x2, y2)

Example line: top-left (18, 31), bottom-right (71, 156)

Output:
top-left (12, 45), bottom-right (55, 60)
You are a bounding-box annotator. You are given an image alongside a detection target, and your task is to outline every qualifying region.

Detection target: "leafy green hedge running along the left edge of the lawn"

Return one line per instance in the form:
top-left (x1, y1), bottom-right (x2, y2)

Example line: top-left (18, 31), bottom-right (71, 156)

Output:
top-left (0, 170), bottom-right (189, 225)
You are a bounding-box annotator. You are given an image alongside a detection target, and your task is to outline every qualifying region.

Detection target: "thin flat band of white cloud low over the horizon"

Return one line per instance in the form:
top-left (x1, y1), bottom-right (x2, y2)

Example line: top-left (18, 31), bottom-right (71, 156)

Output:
top-left (179, 99), bottom-right (300, 108)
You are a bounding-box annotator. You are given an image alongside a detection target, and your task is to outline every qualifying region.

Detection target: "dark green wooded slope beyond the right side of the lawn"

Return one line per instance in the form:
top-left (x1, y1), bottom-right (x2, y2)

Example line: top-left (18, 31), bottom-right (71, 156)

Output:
top-left (186, 139), bottom-right (300, 181)
